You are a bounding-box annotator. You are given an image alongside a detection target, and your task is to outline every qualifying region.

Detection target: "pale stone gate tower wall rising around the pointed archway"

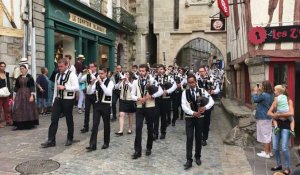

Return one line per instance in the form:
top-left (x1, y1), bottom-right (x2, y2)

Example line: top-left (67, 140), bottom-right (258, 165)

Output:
top-left (135, 0), bottom-right (226, 64)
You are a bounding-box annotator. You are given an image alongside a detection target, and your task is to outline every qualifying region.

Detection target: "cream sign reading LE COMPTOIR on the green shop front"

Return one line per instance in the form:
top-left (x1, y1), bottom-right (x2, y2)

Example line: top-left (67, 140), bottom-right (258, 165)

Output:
top-left (69, 13), bottom-right (106, 34)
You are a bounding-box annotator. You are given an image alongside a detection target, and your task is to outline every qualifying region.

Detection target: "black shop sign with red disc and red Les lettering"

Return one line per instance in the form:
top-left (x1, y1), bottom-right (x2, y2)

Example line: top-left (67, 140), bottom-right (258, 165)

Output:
top-left (248, 25), bottom-right (300, 45)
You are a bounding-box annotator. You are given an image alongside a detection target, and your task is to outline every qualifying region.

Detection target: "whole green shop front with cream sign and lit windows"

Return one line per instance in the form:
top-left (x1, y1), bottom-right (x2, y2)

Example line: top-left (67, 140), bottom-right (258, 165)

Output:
top-left (45, 0), bottom-right (128, 73)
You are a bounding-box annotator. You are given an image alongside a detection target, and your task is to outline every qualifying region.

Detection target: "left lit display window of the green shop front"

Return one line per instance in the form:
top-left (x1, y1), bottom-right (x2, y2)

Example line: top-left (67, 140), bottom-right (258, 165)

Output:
top-left (53, 32), bottom-right (75, 64)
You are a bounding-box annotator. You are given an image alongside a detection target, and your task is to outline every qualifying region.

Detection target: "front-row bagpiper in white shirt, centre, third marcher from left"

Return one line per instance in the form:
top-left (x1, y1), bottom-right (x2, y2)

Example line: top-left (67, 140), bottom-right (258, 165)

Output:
top-left (131, 64), bottom-right (163, 159)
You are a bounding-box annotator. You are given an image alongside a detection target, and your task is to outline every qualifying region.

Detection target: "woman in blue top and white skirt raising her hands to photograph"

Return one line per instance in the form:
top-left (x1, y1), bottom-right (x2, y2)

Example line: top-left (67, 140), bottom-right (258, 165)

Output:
top-left (252, 81), bottom-right (274, 158)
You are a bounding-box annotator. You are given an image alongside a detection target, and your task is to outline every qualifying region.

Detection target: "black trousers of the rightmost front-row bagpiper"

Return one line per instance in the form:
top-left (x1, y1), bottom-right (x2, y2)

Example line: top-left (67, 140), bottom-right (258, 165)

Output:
top-left (185, 117), bottom-right (204, 161)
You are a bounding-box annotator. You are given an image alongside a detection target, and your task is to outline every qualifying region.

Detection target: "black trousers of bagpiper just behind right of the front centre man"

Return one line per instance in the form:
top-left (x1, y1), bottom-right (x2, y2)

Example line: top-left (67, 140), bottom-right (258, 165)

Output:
top-left (154, 98), bottom-right (171, 135)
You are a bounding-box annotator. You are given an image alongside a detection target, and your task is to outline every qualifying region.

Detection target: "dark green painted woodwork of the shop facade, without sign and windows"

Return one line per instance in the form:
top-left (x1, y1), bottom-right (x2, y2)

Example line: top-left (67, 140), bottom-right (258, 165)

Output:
top-left (45, 0), bottom-right (129, 73)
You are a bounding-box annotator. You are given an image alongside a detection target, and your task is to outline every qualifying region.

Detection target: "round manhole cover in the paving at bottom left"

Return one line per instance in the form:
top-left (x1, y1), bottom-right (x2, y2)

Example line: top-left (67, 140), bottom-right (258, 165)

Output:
top-left (16, 160), bottom-right (60, 174)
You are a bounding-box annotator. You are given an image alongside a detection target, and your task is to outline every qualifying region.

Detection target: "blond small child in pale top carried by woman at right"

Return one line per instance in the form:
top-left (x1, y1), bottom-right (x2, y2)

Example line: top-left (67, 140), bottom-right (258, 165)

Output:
top-left (273, 85), bottom-right (296, 137)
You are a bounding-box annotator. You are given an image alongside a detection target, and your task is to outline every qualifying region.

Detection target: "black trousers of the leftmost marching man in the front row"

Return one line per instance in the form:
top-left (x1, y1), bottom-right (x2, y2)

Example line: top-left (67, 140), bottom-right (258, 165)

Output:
top-left (48, 98), bottom-right (74, 142)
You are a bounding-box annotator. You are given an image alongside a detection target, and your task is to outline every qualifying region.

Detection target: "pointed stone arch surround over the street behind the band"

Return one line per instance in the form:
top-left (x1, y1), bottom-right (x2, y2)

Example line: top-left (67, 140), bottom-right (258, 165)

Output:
top-left (170, 32), bottom-right (227, 65)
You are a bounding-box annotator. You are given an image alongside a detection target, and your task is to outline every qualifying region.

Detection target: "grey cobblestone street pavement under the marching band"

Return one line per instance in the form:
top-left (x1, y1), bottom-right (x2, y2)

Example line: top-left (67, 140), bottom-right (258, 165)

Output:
top-left (0, 106), bottom-right (253, 175)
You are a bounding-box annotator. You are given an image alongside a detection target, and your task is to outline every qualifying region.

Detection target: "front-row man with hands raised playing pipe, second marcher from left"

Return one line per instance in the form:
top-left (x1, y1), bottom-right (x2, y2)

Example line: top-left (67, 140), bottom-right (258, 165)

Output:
top-left (86, 67), bottom-right (114, 152)
